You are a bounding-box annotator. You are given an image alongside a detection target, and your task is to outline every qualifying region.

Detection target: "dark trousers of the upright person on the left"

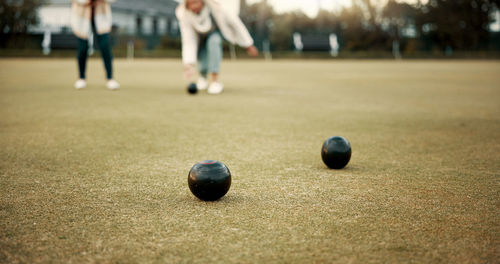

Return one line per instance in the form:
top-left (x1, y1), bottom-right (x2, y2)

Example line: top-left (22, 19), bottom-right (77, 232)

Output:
top-left (77, 21), bottom-right (113, 80)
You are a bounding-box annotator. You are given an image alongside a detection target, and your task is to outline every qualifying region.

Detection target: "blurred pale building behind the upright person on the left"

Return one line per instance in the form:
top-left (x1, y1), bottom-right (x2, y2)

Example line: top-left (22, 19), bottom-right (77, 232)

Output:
top-left (31, 0), bottom-right (179, 36)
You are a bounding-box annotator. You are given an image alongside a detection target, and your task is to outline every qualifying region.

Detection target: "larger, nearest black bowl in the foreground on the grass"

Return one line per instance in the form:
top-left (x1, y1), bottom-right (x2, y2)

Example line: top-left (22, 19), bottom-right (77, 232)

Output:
top-left (188, 160), bottom-right (231, 201)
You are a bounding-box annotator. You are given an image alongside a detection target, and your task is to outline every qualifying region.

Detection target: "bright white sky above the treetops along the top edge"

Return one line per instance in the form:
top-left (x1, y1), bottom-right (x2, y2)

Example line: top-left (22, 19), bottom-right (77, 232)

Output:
top-left (247, 0), bottom-right (417, 17)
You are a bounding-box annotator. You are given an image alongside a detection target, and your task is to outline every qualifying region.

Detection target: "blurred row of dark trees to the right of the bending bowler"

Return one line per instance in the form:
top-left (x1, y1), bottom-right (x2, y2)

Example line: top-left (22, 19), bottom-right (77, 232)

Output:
top-left (238, 0), bottom-right (500, 51)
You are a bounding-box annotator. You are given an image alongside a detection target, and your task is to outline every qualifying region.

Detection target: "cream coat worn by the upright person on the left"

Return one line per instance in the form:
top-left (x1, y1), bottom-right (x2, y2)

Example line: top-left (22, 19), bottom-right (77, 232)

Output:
top-left (71, 0), bottom-right (115, 39)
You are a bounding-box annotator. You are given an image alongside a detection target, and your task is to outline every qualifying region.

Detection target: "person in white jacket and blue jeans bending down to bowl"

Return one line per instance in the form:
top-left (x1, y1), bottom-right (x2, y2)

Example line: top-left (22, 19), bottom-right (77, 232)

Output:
top-left (176, 0), bottom-right (259, 94)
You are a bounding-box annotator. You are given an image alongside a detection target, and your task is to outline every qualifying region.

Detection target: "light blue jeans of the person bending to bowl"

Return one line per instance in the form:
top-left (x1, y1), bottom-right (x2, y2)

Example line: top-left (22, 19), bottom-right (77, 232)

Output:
top-left (198, 31), bottom-right (222, 77)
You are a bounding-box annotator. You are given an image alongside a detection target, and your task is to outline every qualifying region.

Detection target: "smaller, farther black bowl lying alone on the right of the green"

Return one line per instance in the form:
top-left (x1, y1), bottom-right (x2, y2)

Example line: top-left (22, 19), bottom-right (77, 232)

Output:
top-left (321, 137), bottom-right (352, 170)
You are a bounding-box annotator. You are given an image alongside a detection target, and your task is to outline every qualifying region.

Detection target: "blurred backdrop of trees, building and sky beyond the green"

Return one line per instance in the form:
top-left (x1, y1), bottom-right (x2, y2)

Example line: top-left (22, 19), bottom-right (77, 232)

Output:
top-left (0, 0), bottom-right (500, 59)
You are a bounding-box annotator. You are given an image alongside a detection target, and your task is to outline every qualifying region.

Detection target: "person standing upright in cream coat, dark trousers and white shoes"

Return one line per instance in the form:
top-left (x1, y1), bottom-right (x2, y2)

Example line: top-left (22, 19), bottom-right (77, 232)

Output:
top-left (71, 0), bottom-right (120, 90)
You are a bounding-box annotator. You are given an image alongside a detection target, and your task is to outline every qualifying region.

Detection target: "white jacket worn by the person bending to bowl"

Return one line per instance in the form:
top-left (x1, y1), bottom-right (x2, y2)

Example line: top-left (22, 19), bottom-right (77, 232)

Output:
top-left (175, 0), bottom-right (253, 64)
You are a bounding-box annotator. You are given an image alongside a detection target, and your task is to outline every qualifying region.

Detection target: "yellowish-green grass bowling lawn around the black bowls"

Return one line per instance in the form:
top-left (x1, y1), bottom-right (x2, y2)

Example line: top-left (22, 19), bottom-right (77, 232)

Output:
top-left (0, 59), bottom-right (500, 263)
